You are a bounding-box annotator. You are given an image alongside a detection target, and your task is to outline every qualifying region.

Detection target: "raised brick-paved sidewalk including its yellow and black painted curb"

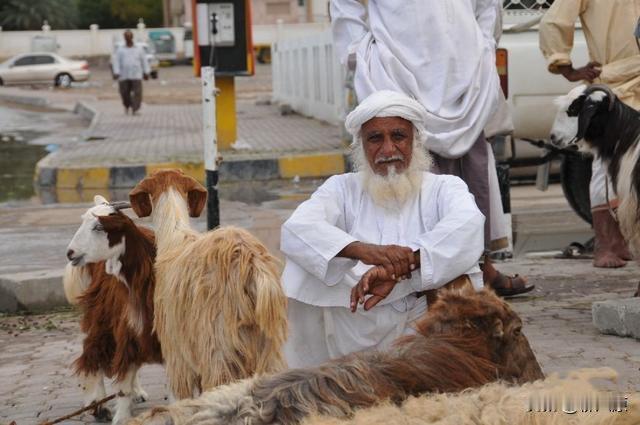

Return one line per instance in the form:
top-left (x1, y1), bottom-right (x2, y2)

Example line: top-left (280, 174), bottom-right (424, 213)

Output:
top-left (0, 84), bottom-right (347, 189)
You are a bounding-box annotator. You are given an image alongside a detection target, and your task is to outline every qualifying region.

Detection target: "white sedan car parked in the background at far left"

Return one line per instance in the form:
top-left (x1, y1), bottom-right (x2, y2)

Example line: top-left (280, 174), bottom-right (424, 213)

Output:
top-left (0, 53), bottom-right (91, 87)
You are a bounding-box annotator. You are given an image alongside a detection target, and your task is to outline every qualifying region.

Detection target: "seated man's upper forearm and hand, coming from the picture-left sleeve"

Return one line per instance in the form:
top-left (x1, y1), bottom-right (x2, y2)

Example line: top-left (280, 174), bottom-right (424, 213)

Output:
top-left (338, 242), bottom-right (418, 281)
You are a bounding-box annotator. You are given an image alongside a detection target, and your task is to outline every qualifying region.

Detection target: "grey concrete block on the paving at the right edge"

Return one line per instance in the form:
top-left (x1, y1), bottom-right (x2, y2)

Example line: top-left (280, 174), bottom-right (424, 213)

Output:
top-left (591, 298), bottom-right (640, 339)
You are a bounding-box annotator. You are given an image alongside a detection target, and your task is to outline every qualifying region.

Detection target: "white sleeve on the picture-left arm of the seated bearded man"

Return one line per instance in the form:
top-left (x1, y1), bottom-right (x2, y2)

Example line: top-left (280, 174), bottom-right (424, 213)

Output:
top-left (280, 178), bottom-right (357, 286)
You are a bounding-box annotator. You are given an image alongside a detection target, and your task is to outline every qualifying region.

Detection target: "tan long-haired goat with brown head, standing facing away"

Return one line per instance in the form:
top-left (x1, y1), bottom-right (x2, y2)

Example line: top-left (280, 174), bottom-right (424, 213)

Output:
top-left (129, 170), bottom-right (287, 398)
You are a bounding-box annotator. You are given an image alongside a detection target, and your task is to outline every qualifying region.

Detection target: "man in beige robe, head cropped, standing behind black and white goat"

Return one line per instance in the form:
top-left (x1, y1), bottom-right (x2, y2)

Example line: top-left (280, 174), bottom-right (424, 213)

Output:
top-left (540, 0), bottom-right (640, 267)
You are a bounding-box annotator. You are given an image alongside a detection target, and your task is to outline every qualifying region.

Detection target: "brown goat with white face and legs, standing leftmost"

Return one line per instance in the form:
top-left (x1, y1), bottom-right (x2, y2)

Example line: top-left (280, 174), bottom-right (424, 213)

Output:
top-left (65, 196), bottom-right (162, 424)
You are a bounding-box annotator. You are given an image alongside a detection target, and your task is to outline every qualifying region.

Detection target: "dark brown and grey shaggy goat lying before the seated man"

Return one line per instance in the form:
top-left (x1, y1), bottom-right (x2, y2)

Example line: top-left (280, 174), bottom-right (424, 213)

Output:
top-left (131, 290), bottom-right (544, 425)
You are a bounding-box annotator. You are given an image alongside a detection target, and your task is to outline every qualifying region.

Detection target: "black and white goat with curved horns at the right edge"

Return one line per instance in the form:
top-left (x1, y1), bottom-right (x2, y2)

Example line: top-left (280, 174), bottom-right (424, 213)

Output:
top-left (551, 84), bottom-right (640, 270)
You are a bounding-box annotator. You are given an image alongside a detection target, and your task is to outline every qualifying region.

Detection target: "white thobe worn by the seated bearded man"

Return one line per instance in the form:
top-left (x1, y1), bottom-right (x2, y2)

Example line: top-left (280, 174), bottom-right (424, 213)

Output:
top-left (280, 173), bottom-right (484, 367)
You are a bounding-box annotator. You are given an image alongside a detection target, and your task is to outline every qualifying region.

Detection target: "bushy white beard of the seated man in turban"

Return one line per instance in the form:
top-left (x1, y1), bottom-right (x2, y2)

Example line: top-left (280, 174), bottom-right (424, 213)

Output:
top-left (351, 134), bottom-right (431, 211)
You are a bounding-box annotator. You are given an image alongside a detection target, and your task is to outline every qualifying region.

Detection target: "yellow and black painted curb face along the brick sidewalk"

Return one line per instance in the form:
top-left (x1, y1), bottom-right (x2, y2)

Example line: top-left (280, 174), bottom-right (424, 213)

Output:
top-left (35, 149), bottom-right (350, 189)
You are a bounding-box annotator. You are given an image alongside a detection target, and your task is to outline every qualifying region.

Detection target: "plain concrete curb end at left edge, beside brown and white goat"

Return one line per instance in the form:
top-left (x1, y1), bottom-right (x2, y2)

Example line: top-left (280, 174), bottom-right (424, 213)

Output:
top-left (0, 269), bottom-right (69, 313)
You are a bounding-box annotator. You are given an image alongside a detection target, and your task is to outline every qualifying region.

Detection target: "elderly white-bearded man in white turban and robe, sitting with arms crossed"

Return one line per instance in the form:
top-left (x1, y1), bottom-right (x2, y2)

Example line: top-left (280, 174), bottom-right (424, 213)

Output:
top-left (280, 91), bottom-right (484, 368)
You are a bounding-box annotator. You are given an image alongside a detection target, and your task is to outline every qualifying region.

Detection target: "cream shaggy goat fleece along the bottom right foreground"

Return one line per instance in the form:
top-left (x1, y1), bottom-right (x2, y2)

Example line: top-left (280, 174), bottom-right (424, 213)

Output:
top-left (303, 368), bottom-right (640, 425)
